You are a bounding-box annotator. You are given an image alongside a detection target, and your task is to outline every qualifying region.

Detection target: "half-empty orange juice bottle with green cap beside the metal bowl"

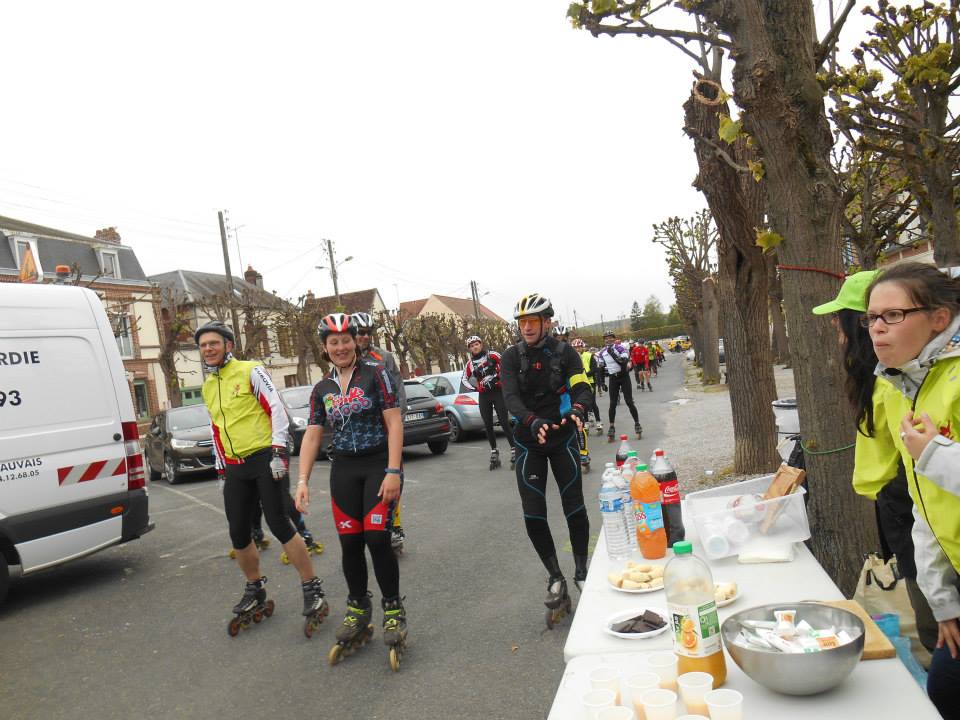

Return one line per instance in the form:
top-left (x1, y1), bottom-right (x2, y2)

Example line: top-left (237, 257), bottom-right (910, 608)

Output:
top-left (663, 540), bottom-right (727, 688)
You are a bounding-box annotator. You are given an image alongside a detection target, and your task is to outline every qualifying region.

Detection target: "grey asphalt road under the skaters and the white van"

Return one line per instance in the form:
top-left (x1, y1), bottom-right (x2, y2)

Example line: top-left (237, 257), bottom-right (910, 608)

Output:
top-left (0, 355), bottom-right (682, 720)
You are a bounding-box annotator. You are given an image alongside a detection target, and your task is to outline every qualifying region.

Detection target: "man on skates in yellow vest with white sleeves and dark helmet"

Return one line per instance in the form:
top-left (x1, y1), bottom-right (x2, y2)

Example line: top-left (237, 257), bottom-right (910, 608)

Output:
top-left (193, 322), bottom-right (329, 635)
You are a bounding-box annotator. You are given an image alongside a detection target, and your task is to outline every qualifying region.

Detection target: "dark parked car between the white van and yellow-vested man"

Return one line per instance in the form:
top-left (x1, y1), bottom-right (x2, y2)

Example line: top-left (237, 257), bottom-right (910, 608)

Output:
top-left (143, 405), bottom-right (215, 485)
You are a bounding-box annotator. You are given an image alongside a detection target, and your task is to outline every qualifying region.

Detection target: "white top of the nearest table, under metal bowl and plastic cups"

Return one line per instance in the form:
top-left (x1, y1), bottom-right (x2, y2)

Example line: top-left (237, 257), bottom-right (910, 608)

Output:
top-left (548, 653), bottom-right (940, 720)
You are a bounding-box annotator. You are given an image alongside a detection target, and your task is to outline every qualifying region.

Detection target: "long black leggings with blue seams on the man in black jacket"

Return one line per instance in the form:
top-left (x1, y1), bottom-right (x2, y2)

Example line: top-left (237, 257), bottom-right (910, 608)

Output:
top-left (517, 430), bottom-right (590, 570)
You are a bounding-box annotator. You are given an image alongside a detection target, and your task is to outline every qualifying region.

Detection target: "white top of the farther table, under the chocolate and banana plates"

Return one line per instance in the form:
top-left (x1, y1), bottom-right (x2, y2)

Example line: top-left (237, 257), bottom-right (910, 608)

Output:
top-left (563, 528), bottom-right (843, 662)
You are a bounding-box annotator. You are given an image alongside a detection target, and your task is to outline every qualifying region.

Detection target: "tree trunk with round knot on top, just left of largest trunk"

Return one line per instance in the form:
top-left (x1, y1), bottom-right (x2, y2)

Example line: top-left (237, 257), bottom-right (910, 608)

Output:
top-left (683, 83), bottom-right (780, 474)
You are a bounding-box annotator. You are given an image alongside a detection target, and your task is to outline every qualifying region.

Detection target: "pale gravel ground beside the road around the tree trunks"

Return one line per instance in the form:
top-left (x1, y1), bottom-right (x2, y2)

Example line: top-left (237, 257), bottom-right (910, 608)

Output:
top-left (663, 360), bottom-right (795, 495)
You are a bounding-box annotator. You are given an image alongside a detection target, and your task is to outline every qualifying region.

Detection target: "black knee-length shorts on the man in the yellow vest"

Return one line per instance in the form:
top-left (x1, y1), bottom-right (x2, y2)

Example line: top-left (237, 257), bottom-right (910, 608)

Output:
top-left (223, 448), bottom-right (296, 550)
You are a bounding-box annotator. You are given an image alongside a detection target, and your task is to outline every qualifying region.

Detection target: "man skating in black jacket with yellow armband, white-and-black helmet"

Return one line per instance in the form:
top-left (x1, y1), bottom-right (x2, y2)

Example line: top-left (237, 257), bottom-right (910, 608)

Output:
top-left (501, 293), bottom-right (590, 627)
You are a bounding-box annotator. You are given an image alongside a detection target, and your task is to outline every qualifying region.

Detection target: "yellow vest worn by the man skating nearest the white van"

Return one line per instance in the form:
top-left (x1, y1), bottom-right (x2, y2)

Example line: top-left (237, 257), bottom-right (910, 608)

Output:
top-left (203, 360), bottom-right (273, 463)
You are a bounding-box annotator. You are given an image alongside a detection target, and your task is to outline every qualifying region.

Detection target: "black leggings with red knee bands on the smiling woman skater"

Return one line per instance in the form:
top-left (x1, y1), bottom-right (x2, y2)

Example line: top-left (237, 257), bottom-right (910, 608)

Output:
top-left (330, 453), bottom-right (400, 599)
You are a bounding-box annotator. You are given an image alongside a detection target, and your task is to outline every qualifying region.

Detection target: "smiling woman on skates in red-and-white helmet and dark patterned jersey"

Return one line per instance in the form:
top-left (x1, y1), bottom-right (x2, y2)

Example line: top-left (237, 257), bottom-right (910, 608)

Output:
top-left (295, 313), bottom-right (407, 670)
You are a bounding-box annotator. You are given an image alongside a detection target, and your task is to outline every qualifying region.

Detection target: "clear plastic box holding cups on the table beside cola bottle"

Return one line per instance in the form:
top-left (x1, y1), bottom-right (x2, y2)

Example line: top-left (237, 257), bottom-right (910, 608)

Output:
top-left (684, 475), bottom-right (810, 560)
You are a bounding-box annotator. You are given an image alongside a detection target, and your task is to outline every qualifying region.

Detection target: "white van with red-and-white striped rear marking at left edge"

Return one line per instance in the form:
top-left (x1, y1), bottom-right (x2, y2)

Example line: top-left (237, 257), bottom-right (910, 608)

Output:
top-left (0, 283), bottom-right (153, 602)
